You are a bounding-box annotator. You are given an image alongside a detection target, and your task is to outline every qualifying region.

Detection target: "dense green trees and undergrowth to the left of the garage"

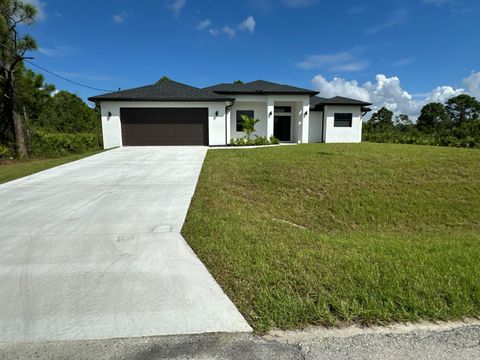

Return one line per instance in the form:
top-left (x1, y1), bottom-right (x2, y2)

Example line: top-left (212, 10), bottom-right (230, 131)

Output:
top-left (0, 0), bottom-right (101, 158)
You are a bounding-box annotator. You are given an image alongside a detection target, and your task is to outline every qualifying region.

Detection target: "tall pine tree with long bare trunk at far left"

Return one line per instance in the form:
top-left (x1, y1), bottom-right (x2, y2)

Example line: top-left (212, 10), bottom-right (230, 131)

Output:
top-left (0, 0), bottom-right (37, 157)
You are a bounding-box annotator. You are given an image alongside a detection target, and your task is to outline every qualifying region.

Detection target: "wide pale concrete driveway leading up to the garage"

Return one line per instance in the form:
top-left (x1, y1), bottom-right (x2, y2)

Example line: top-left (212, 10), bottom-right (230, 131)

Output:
top-left (0, 147), bottom-right (251, 342)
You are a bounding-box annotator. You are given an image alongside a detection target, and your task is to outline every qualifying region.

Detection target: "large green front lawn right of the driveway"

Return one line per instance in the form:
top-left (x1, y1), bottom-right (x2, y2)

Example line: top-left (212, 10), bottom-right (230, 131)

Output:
top-left (182, 143), bottom-right (480, 332)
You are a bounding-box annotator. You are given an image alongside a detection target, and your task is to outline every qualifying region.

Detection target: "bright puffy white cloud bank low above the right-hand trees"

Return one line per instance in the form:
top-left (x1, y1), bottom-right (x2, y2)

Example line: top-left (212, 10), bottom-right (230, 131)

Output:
top-left (312, 74), bottom-right (464, 120)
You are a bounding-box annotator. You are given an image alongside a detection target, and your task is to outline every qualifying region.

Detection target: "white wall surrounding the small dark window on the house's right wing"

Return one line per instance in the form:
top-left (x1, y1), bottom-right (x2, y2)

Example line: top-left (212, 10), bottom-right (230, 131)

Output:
top-left (324, 105), bottom-right (362, 143)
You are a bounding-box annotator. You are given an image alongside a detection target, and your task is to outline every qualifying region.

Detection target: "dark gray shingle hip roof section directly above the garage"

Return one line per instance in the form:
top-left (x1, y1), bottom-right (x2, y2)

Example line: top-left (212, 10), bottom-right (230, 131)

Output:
top-left (88, 80), bottom-right (233, 101)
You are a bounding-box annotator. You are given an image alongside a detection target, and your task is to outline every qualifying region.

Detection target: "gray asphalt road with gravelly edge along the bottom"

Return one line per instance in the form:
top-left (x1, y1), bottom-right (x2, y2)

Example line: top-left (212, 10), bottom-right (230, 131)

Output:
top-left (0, 322), bottom-right (480, 360)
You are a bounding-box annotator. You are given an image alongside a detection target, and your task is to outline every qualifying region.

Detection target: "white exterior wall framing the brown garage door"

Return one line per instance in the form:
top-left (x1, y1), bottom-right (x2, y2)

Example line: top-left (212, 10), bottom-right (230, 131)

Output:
top-left (100, 101), bottom-right (230, 149)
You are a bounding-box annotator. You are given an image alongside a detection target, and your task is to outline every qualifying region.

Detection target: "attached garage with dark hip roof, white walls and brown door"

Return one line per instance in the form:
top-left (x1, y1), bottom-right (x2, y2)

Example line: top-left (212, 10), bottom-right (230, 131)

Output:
top-left (89, 79), bottom-right (235, 149)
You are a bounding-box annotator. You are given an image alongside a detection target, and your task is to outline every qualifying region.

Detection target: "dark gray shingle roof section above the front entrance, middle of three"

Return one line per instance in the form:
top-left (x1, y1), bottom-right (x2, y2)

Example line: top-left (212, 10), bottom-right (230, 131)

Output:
top-left (204, 80), bottom-right (318, 96)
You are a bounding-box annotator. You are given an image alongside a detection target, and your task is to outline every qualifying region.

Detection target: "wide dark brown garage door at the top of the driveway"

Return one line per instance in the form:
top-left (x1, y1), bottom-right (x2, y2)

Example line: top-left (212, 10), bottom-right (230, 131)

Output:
top-left (120, 108), bottom-right (208, 146)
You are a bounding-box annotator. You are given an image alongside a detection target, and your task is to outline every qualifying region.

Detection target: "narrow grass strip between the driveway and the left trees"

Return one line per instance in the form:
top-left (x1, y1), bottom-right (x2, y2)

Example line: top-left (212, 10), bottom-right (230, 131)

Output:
top-left (0, 150), bottom-right (102, 184)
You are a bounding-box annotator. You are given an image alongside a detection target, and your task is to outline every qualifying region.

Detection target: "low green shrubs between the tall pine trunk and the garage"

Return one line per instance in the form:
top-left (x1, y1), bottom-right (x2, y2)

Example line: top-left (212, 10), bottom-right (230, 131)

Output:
top-left (30, 131), bottom-right (102, 157)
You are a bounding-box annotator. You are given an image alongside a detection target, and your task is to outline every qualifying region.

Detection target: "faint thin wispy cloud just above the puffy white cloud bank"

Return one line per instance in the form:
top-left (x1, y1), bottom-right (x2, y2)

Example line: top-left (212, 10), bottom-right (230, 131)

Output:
top-left (297, 48), bottom-right (368, 72)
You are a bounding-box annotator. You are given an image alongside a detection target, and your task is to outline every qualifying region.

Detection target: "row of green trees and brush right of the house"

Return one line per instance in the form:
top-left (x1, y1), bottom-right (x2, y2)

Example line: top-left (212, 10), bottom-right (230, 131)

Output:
top-left (362, 94), bottom-right (480, 148)
